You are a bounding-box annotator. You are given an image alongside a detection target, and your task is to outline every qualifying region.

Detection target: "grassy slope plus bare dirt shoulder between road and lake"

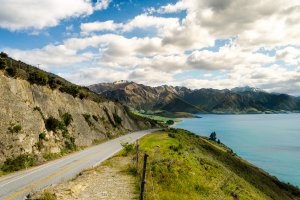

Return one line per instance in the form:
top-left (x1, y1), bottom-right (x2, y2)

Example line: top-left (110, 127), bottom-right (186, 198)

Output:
top-left (33, 129), bottom-right (300, 200)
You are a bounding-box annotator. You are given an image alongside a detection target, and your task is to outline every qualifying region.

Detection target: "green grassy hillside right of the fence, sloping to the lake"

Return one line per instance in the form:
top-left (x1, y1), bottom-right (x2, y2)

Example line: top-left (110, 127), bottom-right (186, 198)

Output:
top-left (130, 129), bottom-right (300, 200)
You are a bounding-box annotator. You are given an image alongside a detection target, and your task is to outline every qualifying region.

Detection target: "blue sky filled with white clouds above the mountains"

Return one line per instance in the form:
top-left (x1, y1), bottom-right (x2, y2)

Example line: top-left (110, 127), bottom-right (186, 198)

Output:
top-left (0, 0), bottom-right (300, 96)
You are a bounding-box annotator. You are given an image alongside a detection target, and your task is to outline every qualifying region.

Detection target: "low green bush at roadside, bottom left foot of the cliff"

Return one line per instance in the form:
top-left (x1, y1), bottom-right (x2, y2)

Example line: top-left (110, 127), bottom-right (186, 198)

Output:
top-left (1, 154), bottom-right (36, 172)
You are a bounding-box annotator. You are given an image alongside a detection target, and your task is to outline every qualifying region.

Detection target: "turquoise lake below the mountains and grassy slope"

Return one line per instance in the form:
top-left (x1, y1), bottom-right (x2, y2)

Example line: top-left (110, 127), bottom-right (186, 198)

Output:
top-left (175, 114), bottom-right (300, 186)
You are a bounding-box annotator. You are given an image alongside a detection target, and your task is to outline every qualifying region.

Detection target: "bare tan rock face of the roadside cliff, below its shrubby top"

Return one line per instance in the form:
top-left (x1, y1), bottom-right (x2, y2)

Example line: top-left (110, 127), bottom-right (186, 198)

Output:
top-left (0, 72), bottom-right (151, 164)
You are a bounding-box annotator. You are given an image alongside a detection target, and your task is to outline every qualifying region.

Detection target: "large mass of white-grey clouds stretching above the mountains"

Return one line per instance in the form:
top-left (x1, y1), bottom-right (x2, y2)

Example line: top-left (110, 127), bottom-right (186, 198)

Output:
top-left (0, 0), bottom-right (300, 94)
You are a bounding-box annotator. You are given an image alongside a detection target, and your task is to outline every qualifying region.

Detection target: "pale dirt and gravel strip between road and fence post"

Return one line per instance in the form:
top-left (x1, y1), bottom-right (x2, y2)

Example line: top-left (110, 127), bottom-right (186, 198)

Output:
top-left (32, 157), bottom-right (138, 200)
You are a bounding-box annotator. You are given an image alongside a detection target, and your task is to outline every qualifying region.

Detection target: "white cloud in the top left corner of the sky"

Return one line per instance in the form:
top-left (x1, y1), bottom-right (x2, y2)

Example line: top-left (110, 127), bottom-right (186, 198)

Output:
top-left (0, 0), bottom-right (110, 31)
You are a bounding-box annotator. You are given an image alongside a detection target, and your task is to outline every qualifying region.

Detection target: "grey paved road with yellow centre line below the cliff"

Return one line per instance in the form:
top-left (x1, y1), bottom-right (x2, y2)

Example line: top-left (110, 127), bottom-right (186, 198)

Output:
top-left (0, 129), bottom-right (158, 200)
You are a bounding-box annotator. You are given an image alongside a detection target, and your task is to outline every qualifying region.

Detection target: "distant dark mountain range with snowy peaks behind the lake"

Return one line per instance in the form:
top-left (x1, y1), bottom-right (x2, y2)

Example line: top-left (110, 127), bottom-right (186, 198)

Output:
top-left (88, 81), bottom-right (300, 113)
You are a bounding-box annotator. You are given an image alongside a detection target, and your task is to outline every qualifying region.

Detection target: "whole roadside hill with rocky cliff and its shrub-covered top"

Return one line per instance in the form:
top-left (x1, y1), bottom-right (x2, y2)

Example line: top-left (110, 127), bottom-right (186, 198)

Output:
top-left (0, 56), bottom-right (156, 172)
